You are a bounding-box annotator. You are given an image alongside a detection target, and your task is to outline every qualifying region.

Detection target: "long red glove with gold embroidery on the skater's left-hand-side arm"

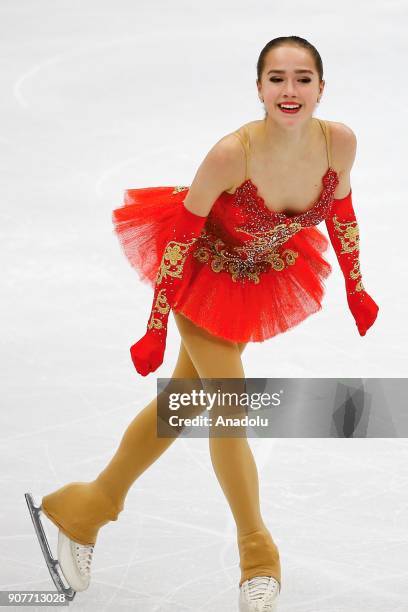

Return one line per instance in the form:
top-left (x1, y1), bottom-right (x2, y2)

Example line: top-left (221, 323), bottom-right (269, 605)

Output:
top-left (130, 203), bottom-right (207, 376)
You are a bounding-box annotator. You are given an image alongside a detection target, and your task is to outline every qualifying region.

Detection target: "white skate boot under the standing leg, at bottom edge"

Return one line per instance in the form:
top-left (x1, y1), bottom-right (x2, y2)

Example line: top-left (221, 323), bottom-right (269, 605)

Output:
top-left (239, 576), bottom-right (280, 612)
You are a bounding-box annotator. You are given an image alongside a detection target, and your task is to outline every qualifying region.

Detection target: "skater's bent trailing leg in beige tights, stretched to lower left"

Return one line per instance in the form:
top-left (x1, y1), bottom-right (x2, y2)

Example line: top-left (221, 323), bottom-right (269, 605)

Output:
top-left (41, 342), bottom-right (223, 545)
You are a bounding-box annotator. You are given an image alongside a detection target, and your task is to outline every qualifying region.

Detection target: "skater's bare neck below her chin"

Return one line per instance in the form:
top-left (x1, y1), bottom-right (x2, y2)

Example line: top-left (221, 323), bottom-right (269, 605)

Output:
top-left (262, 115), bottom-right (317, 158)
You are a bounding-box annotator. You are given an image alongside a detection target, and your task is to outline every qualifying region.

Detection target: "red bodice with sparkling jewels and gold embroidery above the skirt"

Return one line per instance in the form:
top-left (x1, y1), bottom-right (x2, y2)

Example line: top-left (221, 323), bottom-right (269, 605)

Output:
top-left (190, 167), bottom-right (339, 283)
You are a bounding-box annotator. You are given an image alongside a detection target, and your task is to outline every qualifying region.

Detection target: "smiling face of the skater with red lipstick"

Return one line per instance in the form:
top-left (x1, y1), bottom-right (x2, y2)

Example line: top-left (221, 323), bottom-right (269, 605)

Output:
top-left (257, 45), bottom-right (324, 125)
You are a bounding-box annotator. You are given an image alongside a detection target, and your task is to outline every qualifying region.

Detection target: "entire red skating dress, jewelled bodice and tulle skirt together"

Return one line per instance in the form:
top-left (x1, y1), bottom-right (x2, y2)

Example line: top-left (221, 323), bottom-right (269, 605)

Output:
top-left (113, 166), bottom-right (339, 342)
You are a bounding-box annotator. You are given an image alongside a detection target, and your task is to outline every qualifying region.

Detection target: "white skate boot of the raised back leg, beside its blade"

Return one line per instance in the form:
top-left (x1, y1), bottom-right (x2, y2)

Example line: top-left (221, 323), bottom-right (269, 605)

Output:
top-left (58, 530), bottom-right (94, 591)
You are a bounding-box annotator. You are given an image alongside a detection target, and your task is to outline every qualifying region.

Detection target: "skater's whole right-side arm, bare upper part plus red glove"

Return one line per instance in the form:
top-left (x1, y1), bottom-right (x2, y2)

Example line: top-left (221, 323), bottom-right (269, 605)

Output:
top-left (326, 126), bottom-right (378, 336)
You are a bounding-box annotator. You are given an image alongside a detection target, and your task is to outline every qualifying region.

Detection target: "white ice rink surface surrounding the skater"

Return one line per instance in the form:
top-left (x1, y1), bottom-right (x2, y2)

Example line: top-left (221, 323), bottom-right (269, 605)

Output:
top-left (0, 0), bottom-right (408, 612)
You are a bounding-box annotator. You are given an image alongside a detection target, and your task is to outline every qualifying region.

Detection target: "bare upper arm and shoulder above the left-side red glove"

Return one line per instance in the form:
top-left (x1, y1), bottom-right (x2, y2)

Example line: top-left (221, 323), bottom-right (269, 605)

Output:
top-left (184, 126), bottom-right (245, 216)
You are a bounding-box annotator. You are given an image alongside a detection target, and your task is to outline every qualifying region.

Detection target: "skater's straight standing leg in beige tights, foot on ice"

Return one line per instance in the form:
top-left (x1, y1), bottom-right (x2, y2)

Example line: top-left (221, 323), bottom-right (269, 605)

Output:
top-left (174, 313), bottom-right (281, 585)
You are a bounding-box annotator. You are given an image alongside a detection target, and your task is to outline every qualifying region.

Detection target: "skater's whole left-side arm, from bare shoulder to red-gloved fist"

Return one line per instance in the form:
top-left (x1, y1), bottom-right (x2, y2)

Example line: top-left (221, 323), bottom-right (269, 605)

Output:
top-left (130, 135), bottom-right (242, 376)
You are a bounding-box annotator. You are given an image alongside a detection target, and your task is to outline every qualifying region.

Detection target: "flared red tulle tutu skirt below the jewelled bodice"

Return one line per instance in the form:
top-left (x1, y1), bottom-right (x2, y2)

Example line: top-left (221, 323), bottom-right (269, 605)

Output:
top-left (112, 187), bottom-right (331, 342)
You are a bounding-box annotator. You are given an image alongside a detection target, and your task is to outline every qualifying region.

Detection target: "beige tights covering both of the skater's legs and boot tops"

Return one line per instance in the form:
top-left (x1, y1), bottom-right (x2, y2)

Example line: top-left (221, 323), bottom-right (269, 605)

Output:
top-left (42, 312), bottom-right (281, 585)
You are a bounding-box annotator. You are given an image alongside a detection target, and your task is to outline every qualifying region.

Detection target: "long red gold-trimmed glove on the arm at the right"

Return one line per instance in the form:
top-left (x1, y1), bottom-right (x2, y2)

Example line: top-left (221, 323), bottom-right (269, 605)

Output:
top-left (326, 189), bottom-right (378, 336)
